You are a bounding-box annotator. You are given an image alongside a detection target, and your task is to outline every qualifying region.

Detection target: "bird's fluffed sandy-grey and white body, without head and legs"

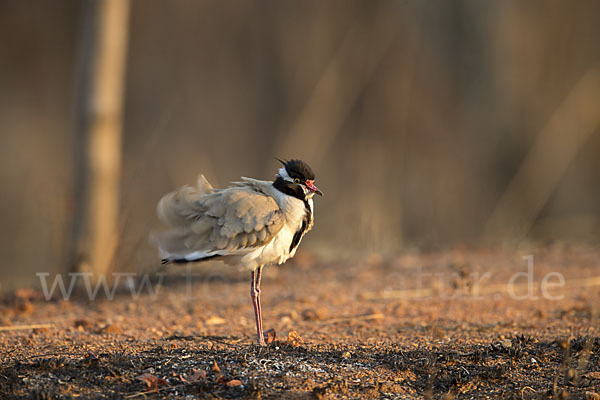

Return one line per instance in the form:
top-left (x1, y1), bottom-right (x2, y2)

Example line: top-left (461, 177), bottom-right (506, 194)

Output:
top-left (155, 178), bottom-right (302, 268)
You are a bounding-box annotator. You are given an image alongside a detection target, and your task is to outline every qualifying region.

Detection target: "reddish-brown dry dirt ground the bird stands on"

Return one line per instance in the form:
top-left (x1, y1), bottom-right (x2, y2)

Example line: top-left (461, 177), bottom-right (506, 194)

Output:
top-left (0, 244), bottom-right (600, 399)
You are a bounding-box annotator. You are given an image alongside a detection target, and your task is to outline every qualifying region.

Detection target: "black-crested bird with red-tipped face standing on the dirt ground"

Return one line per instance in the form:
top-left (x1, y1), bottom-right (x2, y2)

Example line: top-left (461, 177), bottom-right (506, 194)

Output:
top-left (154, 159), bottom-right (323, 346)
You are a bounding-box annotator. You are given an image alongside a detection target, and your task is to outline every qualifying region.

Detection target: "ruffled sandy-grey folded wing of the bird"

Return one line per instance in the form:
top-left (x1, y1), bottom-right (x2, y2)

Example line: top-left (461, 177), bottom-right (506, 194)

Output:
top-left (158, 185), bottom-right (285, 256)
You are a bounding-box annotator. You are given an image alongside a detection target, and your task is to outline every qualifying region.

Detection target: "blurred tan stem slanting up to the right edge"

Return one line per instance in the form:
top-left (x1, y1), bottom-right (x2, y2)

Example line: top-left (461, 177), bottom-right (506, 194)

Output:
top-left (484, 67), bottom-right (600, 242)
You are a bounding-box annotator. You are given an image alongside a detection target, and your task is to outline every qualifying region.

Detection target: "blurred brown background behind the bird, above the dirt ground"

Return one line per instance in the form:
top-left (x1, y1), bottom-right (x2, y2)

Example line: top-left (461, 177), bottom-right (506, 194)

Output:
top-left (0, 0), bottom-right (600, 290)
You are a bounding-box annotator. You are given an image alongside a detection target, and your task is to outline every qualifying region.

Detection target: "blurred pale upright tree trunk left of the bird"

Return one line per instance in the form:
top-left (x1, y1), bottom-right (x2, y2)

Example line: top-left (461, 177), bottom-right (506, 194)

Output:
top-left (71, 0), bottom-right (130, 277)
